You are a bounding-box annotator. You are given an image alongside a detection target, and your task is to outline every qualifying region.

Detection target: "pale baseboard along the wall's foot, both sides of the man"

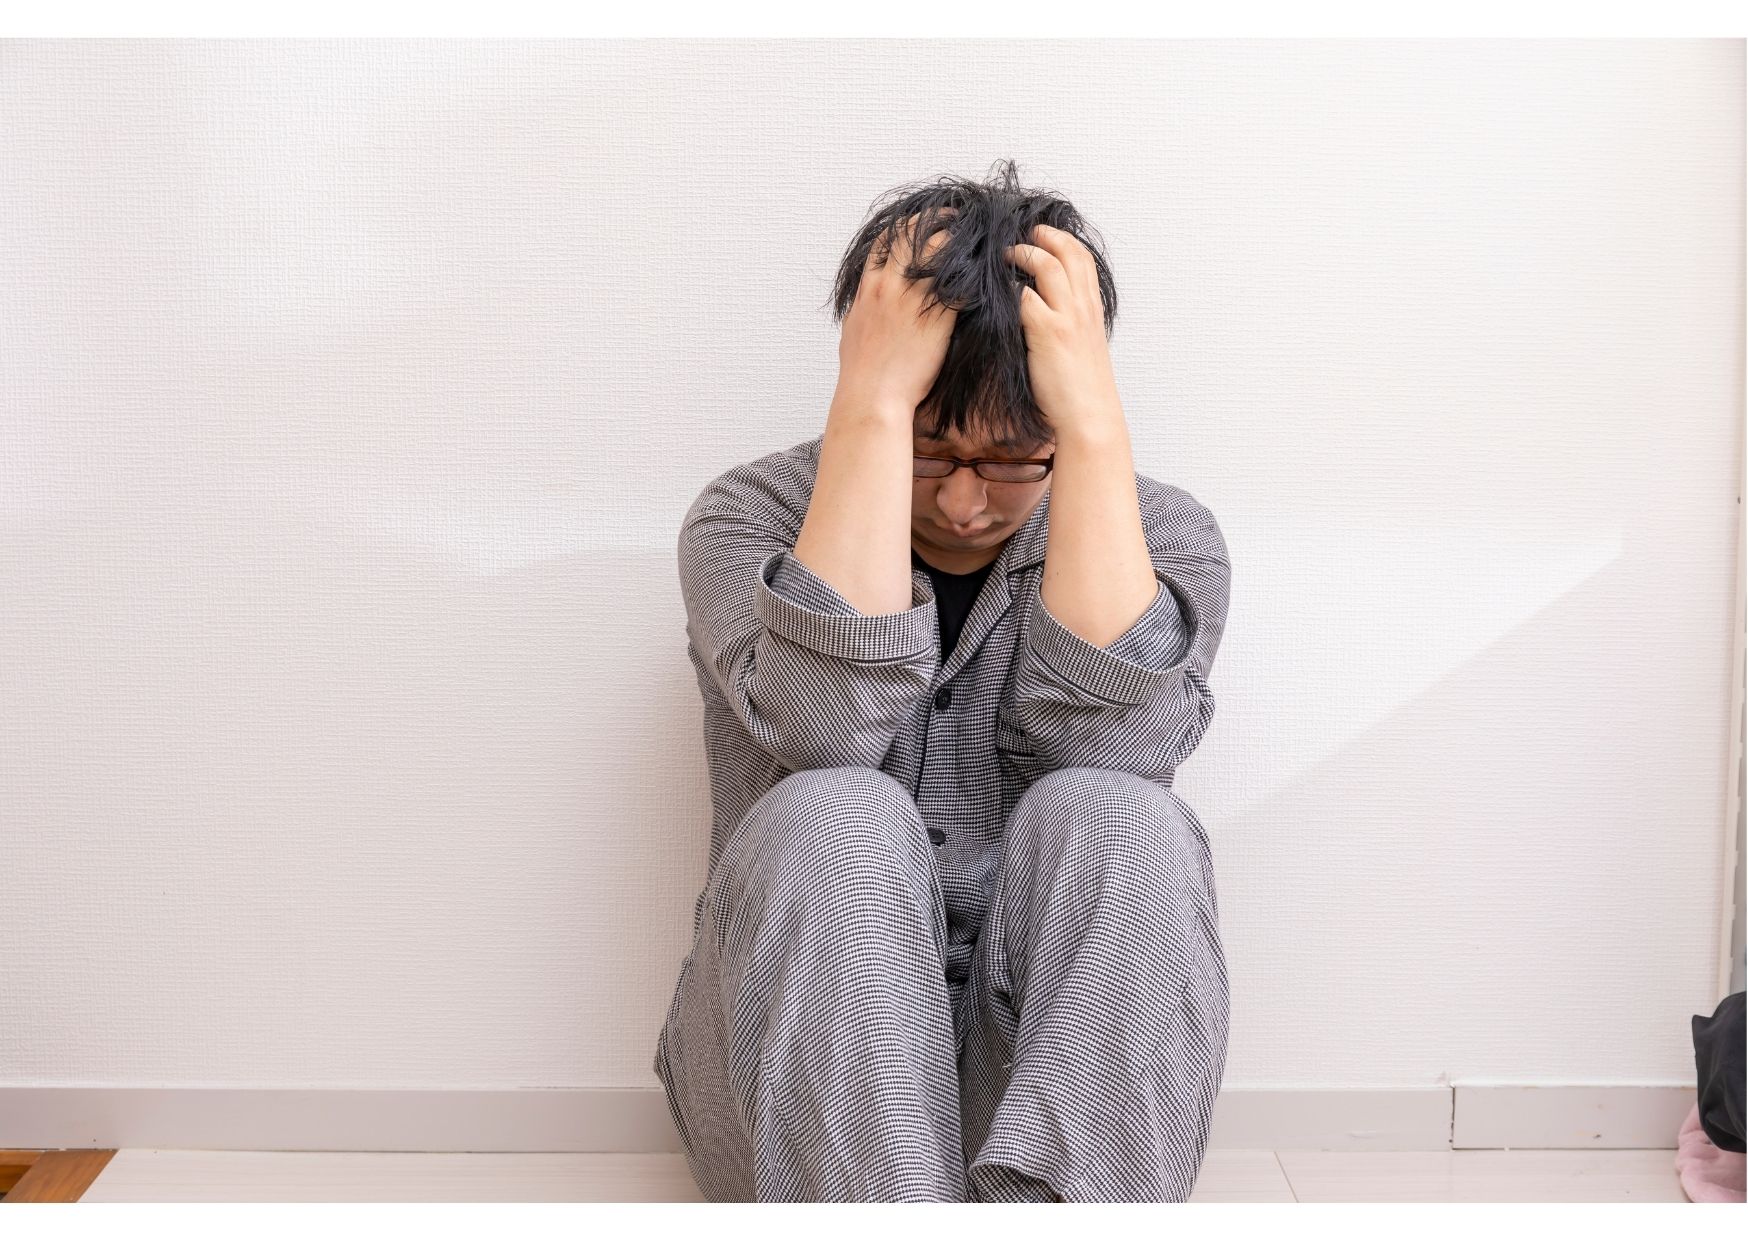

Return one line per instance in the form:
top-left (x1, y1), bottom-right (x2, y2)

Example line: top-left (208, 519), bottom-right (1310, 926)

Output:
top-left (0, 1084), bottom-right (1696, 1153)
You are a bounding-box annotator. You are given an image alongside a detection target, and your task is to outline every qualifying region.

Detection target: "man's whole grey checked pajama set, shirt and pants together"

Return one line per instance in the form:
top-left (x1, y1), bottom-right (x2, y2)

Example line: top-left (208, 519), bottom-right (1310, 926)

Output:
top-left (654, 437), bottom-right (1231, 1202)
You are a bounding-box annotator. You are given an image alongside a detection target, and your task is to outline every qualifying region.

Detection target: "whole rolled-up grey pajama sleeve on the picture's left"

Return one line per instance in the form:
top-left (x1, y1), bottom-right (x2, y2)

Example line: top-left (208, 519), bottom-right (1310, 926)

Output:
top-left (680, 516), bottom-right (940, 771)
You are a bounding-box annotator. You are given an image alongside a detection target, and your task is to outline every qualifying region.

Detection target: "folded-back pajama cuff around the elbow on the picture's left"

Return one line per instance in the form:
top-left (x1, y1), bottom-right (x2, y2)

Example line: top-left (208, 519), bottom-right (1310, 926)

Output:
top-left (753, 547), bottom-right (939, 663)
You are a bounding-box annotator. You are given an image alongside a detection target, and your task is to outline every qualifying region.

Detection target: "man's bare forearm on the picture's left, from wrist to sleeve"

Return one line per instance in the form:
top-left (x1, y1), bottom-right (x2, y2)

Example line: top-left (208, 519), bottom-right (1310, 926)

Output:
top-left (794, 394), bottom-right (916, 616)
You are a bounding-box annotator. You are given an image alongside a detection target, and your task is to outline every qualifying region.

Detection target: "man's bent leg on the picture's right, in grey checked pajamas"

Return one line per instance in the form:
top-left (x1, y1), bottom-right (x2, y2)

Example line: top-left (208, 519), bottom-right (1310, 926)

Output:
top-left (961, 768), bottom-right (1227, 1202)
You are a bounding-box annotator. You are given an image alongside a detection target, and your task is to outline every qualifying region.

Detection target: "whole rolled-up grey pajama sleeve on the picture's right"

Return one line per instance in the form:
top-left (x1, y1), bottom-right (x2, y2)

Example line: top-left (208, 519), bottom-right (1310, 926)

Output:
top-left (1002, 491), bottom-right (1231, 787)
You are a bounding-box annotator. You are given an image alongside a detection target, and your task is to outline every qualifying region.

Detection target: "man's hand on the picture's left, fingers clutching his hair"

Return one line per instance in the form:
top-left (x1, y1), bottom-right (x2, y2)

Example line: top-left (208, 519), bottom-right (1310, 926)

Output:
top-left (837, 208), bottom-right (958, 413)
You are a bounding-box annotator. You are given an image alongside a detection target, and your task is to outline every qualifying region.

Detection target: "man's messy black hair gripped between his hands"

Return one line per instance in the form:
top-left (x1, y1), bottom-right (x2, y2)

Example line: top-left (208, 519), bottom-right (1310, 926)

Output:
top-left (832, 159), bottom-right (1117, 446)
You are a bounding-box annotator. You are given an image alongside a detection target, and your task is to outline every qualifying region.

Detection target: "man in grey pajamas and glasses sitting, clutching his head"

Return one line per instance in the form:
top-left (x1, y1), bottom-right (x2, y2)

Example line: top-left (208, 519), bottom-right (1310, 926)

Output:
top-left (654, 166), bottom-right (1229, 1202)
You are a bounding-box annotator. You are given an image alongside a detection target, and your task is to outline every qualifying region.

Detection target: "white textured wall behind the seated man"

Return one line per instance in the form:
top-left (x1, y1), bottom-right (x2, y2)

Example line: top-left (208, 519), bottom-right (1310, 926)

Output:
top-left (0, 40), bottom-right (1743, 1086)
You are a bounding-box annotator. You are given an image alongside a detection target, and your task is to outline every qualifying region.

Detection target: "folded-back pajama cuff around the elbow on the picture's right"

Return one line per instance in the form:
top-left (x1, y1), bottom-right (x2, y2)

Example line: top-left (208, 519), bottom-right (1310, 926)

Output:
top-left (1026, 570), bottom-right (1192, 707)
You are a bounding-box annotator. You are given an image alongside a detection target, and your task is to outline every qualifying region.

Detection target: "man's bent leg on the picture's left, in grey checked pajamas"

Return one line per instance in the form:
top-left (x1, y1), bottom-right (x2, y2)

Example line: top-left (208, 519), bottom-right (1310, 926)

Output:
top-left (656, 768), bottom-right (965, 1202)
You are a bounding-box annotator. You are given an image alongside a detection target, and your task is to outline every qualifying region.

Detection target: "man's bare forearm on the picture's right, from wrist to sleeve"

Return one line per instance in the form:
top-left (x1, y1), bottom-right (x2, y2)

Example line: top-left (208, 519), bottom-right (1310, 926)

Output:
top-left (1040, 409), bottom-right (1161, 647)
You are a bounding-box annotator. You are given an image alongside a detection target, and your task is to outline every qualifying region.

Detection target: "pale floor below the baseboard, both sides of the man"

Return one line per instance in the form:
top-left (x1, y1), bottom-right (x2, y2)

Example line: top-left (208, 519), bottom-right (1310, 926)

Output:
top-left (41, 1149), bottom-right (1687, 1202)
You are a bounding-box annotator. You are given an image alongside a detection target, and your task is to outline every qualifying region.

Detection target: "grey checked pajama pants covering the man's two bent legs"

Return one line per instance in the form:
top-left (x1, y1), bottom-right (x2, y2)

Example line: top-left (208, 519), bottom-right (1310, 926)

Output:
top-left (656, 768), bottom-right (1227, 1202)
